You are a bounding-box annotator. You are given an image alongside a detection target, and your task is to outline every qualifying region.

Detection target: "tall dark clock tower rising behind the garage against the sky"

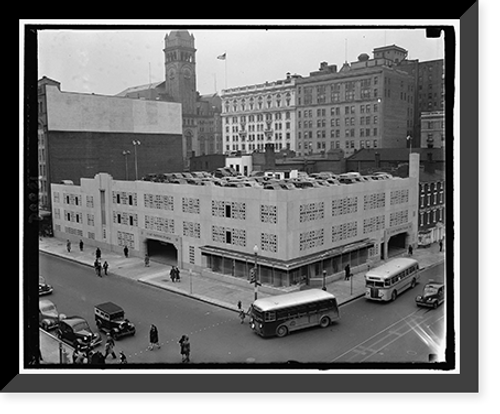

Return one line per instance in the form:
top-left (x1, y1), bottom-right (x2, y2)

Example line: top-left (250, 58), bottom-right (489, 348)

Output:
top-left (163, 30), bottom-right (196, 116)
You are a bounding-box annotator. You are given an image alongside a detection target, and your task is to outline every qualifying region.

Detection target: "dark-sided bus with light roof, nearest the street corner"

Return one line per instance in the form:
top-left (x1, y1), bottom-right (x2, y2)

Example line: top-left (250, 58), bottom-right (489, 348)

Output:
top-left (250, 289), bottom-right (340, 337)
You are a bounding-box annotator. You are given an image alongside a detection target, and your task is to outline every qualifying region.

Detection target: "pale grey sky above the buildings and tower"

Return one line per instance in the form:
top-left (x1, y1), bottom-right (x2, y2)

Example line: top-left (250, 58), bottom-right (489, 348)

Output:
top-left (38, 20), bottom-right (444, 95)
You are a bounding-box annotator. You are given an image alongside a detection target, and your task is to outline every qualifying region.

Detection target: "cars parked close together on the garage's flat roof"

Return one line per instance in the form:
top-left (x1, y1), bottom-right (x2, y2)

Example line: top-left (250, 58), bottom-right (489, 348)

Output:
top-left (143, 167), bottom-right (399, 190)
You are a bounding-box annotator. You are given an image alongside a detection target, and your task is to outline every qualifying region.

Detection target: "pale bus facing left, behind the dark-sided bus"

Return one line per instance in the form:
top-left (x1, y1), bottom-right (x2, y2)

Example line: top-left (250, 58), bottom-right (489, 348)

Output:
top-left (365, 258), bottom-right (420, 301)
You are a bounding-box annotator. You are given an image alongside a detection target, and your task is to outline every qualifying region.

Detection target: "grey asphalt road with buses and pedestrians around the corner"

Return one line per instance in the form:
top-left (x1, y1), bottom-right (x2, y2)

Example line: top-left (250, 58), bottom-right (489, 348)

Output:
top-left (39, 253), bottom-right (444, 368)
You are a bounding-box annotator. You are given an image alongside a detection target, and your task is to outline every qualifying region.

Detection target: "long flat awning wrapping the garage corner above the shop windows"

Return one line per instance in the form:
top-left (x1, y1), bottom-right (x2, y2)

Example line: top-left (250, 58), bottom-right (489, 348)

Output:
top-left (200, 239), bottom-right (375, 271)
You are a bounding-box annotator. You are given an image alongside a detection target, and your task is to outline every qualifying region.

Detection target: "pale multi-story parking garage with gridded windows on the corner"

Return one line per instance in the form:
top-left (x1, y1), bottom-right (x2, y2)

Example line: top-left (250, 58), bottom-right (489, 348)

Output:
top-left (51, 154), bottom-right (419, 287)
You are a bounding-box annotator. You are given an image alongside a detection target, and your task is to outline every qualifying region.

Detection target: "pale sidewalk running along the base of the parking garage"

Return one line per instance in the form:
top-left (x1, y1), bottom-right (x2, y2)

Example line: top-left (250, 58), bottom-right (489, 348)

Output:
top-left (39, 237), bottom-right (444, 311)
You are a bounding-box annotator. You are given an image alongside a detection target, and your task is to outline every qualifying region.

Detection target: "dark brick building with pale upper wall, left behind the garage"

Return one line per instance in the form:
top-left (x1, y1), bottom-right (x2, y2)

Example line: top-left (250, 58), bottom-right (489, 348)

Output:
top-left (38, 78), bottom-right (182, 211)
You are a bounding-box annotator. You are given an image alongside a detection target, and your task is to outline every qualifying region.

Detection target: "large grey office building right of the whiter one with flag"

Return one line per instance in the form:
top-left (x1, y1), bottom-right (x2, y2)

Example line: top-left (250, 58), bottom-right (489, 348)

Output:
top-left (296, 45), bottom-right (415, 156)
